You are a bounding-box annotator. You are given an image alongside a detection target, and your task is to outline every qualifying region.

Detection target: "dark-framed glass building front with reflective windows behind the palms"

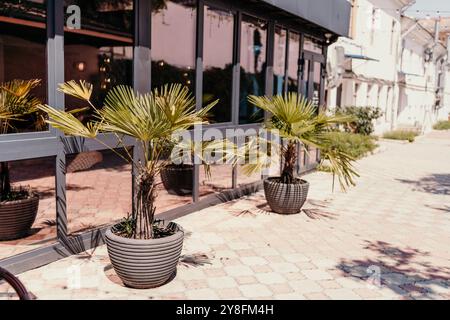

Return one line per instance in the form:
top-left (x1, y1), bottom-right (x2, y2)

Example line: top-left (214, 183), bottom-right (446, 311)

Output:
top-left (0, 0), bottom-right (350, 272)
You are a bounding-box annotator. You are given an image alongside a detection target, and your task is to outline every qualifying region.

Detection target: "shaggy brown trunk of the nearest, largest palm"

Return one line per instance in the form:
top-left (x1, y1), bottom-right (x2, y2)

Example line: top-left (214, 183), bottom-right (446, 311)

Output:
top-left (133, 172), bottom-right (156, 239)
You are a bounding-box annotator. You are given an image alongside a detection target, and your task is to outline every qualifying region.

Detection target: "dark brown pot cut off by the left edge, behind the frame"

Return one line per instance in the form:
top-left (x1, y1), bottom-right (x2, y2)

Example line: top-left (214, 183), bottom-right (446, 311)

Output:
top-left (0, 196), bottom-right (39, 241)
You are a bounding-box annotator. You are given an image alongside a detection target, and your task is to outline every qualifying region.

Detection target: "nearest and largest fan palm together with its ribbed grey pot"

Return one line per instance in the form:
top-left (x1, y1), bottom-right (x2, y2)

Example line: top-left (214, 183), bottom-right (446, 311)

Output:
top-left (40, 81), bottom-right (217, 288)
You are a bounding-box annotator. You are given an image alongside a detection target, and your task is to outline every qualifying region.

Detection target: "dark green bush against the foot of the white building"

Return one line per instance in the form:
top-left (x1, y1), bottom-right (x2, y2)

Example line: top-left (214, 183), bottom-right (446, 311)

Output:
top-left (336, 106), bottom-right (383, 136)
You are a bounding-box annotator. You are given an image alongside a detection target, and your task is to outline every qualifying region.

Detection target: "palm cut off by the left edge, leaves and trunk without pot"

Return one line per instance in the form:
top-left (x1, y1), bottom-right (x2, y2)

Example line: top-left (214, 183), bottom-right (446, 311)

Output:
top-left (0, 80), bottom-right (41, 201)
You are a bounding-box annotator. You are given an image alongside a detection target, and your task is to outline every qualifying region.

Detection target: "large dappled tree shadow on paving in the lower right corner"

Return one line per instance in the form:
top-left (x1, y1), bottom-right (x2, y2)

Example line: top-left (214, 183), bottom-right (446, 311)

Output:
top-left (337, 241), bottom-right (450, 299)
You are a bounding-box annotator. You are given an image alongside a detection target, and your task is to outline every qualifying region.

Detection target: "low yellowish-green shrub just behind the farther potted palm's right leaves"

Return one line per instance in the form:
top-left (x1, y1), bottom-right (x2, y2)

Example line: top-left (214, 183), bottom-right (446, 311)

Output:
top-left (327, 132), bottom-right (378, 159)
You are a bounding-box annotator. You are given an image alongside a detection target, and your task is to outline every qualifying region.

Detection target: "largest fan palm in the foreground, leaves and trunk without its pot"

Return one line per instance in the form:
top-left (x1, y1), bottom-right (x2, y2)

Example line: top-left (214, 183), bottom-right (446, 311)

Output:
top-left (39, 81), bottom-right (217, 239)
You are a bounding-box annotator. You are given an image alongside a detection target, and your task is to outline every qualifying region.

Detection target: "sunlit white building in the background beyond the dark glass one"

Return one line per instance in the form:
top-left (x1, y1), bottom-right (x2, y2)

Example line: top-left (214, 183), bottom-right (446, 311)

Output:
top-left (327, 0), bottom-right (448, 134)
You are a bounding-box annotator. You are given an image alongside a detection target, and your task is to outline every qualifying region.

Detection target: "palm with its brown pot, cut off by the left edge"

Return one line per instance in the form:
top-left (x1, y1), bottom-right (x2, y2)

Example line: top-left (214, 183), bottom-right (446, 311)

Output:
top-left (0, 80), bottom-right (42, 241)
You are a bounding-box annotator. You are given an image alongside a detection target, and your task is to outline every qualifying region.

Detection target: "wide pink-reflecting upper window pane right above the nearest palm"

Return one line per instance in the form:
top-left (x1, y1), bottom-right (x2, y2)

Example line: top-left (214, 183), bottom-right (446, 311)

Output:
top-left (152, 0), bottom-right (196, 91)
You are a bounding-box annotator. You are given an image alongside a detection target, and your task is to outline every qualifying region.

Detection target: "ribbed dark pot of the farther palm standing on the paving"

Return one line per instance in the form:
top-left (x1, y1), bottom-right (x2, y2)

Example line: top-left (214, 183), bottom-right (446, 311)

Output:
top-left (264, 178), bottom-right (309, 214)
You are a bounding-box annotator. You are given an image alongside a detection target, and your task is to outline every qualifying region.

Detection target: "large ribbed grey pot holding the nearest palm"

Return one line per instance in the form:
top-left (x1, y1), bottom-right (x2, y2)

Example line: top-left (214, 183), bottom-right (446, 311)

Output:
top-left (105, 225), bottom-right (184, 289)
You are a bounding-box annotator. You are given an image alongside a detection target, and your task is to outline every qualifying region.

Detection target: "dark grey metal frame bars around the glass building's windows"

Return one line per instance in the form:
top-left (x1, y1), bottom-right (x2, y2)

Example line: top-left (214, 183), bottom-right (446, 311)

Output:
top-left (0, 0), bottom-right (326, 273)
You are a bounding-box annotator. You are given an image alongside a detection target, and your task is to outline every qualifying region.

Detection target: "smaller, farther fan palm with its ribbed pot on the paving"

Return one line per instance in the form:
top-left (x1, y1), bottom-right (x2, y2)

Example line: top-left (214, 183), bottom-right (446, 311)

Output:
top-left (245, 93), bottom-right (358, 214)
